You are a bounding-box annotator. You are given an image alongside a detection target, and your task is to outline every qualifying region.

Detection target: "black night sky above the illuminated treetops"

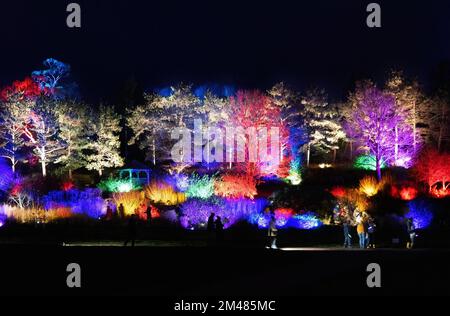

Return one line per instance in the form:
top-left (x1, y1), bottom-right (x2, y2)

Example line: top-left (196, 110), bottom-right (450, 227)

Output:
top-left (0, 0), bottom-right (450, 100)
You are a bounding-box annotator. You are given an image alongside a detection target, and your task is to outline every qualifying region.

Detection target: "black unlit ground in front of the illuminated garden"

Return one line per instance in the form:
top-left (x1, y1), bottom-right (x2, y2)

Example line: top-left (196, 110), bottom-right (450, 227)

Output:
top-left (0, 242), bottom-right (450, 298)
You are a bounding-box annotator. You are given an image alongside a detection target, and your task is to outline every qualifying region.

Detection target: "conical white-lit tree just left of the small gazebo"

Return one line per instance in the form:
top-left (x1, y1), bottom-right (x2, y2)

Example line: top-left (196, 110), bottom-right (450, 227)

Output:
top-left (85, 106), bottom-right (124, 176)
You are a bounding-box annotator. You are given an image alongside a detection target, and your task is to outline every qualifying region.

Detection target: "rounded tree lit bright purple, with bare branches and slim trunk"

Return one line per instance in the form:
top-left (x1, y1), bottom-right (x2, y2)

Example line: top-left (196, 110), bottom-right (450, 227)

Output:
top-left (349, 85), bottom-right (407, 180)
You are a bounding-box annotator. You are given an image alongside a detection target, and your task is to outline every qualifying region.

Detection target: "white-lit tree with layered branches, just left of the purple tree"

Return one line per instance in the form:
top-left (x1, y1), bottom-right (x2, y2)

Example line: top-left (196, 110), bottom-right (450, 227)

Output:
top-left (302, 89), bottom-right (345, 166)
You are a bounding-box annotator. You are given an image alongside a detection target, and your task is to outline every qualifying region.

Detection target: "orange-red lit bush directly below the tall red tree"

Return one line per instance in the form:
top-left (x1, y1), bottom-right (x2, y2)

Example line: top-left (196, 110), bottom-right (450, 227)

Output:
top-left (214, 174), bottom-right (258, 199)
